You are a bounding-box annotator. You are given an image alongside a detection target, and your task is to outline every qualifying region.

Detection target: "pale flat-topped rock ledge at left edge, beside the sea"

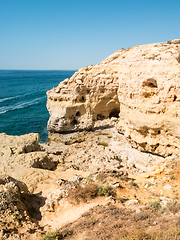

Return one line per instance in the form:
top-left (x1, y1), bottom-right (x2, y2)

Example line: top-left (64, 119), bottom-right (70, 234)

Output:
top-left (0, 133), bottom-right (59, 191)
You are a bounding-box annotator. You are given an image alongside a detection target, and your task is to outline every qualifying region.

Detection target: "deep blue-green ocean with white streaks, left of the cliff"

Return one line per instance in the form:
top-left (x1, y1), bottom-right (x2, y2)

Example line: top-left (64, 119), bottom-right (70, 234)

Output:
top-left (0, 70), bottom-right (75, 143)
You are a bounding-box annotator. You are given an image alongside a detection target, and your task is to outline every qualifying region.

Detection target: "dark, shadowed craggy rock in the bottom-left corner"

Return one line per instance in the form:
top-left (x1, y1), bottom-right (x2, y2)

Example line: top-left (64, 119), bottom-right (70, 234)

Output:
top-left (0, 175), bottom-right (40, 240)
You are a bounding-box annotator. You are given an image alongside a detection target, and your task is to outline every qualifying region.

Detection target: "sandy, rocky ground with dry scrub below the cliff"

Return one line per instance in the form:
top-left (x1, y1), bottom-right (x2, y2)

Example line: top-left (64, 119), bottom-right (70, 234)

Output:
top-left (0, 130), bottom-right (180, 240)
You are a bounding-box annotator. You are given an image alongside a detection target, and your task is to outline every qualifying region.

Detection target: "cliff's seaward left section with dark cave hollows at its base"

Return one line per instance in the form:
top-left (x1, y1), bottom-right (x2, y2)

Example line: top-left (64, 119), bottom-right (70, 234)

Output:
top-left (47, 62), bottom-right (119, 132)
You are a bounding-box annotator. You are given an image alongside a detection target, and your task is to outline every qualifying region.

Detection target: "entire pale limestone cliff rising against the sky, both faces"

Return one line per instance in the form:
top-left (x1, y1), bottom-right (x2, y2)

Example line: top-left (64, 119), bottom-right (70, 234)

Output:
top-left (47, 40), bottom-right (180, 156)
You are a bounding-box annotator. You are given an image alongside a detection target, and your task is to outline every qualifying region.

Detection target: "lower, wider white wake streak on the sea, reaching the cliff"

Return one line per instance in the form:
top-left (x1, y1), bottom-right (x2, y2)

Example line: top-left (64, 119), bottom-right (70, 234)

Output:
top-left (0, 96), bottom-right (46, 114)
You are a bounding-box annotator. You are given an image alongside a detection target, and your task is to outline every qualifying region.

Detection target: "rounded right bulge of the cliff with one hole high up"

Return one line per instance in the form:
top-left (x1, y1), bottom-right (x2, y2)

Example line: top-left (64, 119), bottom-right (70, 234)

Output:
top-left (118, 40), bottom-right (180, 156)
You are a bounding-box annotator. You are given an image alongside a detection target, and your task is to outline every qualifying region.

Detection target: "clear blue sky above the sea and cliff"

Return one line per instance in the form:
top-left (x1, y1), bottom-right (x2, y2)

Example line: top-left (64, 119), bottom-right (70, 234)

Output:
top-left (0, 0), bottom-right (180, 70)
